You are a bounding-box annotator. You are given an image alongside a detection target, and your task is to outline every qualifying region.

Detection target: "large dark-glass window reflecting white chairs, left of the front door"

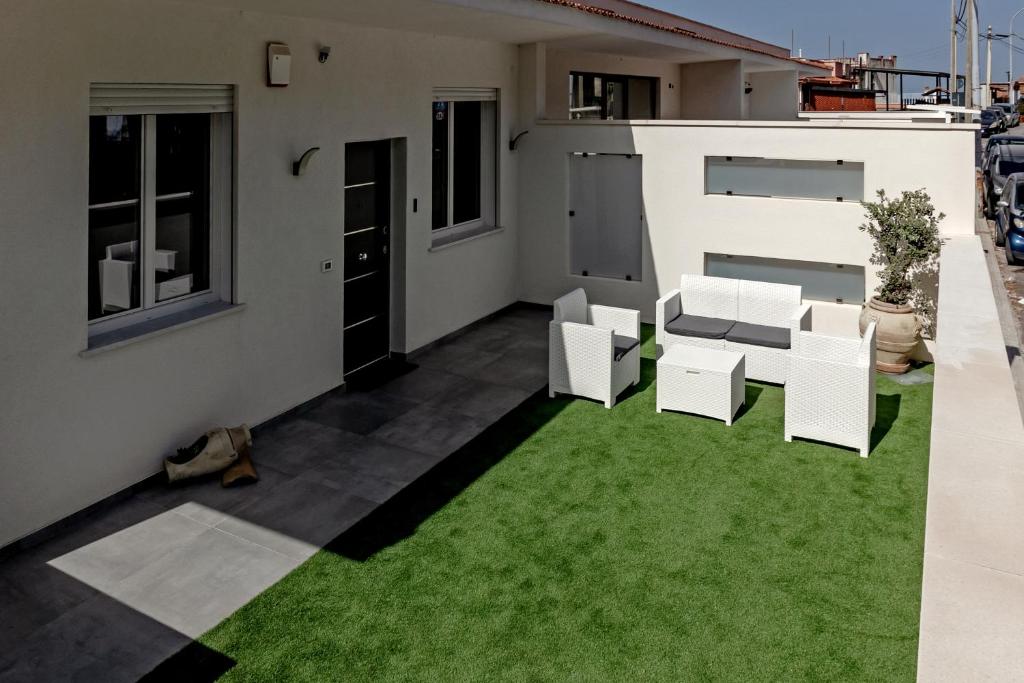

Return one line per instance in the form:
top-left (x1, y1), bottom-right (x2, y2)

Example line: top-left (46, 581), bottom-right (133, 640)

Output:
top-left (88, 109), bottom-right (230, 332)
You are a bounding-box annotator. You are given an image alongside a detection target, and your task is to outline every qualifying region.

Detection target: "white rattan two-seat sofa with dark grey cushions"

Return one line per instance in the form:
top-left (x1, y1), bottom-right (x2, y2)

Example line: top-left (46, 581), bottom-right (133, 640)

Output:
top-left (655, 274), bottom-right (811, 384)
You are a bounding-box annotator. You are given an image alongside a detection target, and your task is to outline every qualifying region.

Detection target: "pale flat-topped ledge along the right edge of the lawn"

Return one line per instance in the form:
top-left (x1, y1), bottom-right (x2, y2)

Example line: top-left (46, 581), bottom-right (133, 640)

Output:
top-left (918, 237), bottom-right (1024, 681)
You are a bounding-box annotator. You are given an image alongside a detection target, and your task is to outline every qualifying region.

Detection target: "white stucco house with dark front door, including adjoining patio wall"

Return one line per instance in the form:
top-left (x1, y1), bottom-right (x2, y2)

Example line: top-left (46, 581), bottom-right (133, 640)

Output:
top-left (0, 0), bottom-right (974, 546)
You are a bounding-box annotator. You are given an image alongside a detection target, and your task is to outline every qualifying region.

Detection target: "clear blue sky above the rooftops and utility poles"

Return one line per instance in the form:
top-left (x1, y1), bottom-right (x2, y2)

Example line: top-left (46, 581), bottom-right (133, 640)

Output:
top-left (639, 0), bottom-right (1024, 81)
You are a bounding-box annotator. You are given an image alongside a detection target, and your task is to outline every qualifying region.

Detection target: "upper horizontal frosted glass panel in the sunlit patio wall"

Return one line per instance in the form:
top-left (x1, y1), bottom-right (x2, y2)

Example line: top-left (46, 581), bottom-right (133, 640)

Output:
top-left (705, 157), bottom-right (864, 202)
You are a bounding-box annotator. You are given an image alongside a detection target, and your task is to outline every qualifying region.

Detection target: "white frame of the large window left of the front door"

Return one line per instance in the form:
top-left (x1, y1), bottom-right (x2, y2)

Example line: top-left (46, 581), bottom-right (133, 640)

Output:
top-left (88, 112), bottom-right (234, 338)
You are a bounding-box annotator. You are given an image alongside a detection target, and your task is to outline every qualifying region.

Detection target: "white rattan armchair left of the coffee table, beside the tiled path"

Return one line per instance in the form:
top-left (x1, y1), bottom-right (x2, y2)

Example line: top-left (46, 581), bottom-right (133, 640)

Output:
top-left (548, 289), bottom-right (640, 408)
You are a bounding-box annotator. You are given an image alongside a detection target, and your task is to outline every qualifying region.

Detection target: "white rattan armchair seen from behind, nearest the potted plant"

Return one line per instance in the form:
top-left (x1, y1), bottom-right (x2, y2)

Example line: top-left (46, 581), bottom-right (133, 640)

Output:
top-left (785, 323), bottom-right (876, 458)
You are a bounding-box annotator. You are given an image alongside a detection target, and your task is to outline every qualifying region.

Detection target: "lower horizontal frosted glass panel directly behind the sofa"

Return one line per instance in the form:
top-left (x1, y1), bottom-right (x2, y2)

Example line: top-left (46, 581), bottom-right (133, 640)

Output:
top-left (705, 254), bottom-right (864, 304)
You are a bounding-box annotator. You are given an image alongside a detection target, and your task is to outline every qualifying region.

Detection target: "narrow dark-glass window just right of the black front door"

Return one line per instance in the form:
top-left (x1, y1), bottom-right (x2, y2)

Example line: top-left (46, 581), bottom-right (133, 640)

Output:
top-left (431, 100), bottom-right (497, 230)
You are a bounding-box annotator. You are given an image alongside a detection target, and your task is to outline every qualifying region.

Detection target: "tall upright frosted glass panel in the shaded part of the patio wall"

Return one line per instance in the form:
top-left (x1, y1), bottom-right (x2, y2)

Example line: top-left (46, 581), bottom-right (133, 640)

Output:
top-left (569, 154), bottom-right (643, 281)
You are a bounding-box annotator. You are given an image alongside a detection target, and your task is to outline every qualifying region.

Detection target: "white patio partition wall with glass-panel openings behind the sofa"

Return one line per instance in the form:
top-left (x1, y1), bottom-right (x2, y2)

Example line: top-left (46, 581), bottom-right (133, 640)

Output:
top-left (519, 121), bottom-right (974, 334)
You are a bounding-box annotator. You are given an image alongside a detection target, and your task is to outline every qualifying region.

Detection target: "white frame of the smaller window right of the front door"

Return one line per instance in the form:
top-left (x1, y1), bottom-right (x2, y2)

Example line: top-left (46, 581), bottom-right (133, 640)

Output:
top-left (430, 88), bottom-right (502, 242)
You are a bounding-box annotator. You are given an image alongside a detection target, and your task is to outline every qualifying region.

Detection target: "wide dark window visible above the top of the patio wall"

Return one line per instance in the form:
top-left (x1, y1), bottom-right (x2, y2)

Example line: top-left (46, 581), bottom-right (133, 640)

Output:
top-left (569, 72), bottom-right (657, 120)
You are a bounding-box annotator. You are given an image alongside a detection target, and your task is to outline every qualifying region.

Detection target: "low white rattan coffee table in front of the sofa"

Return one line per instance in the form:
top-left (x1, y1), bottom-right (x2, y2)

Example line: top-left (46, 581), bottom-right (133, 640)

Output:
top-left (657, 344), bottom-right (745, 425)
